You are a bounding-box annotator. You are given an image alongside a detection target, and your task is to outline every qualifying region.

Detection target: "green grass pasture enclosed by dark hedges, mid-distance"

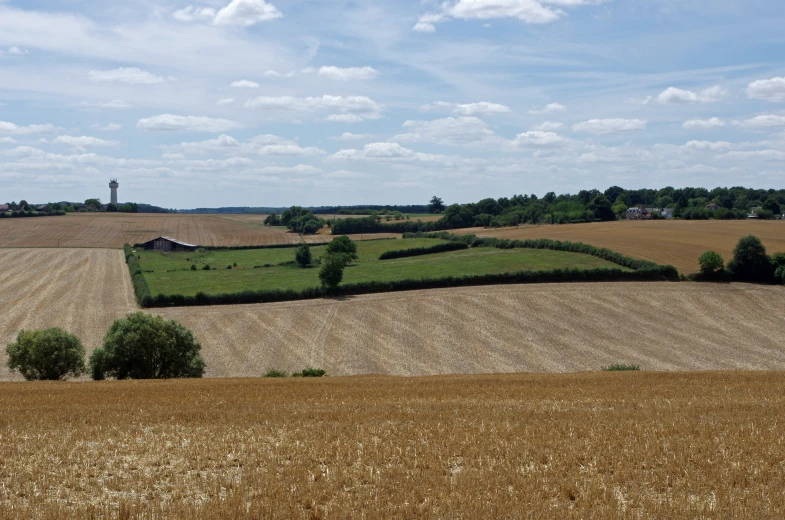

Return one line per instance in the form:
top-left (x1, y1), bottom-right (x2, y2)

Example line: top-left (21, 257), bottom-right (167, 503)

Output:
top-left (137, 238), bottom-right (623, 296)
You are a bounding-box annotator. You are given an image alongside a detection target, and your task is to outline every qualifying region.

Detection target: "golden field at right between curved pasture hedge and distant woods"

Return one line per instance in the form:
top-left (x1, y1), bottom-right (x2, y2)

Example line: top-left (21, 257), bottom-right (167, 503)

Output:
top-left (454, 220), bottom-right (785, 273)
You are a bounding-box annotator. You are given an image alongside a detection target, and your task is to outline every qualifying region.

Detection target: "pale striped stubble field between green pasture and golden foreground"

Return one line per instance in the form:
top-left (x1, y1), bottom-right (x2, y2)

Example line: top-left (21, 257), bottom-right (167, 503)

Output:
top-left (152, 282), bottom-right (785, 377)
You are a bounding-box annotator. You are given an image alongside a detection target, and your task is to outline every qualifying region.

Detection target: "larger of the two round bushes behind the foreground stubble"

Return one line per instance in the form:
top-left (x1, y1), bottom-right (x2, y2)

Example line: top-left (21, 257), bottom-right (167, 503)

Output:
top-left (90, 312), bottom-right (204, 380)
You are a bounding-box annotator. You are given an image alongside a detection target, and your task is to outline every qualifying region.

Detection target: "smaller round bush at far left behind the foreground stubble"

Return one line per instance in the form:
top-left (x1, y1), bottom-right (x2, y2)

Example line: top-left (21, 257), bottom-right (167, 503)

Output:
top-left (6, 328), bottom-right (85, 381)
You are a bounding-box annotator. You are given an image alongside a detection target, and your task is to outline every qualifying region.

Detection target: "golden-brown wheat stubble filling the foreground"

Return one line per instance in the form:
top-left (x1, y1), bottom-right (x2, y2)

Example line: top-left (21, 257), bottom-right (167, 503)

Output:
top-left (0, 372), bottom-right (785, 519)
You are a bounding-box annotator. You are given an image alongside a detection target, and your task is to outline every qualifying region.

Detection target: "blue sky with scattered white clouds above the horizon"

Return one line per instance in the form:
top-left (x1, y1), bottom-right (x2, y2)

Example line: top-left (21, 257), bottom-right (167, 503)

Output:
top-left (0, 0), bottom-right (785, 208)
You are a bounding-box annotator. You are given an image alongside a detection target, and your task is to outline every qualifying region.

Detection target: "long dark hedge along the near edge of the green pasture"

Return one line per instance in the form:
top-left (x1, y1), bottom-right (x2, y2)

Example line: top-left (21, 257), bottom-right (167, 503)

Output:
top-left (139, 264), bottom-right (678, 307)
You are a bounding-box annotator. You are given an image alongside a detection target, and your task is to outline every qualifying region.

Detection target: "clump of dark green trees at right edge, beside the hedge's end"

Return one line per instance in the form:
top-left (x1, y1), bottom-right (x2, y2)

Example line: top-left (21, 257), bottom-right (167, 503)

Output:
top-left (693, 235), bottom-right (785, 284)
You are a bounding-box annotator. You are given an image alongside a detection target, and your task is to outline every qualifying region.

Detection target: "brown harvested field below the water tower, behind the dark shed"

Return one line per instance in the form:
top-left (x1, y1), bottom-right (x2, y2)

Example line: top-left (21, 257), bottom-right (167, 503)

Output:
top-left (0, 213), bottom-right (400, 248)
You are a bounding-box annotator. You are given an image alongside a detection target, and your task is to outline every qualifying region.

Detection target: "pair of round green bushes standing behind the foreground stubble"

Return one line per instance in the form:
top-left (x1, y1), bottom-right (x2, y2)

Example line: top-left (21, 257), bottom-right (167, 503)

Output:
top-left (6, 312), bottom-right (205, 381)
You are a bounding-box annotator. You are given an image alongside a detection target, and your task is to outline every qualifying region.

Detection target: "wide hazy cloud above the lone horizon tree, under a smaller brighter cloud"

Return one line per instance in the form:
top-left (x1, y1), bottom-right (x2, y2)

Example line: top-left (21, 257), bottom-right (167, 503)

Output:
top-left (391, 117), bottom-right (496, 146)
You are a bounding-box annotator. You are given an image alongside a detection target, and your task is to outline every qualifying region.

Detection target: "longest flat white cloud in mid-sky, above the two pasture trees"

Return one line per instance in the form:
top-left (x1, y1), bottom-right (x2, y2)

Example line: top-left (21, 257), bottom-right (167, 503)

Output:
top-left (245, 95), bottom-right (382, 123)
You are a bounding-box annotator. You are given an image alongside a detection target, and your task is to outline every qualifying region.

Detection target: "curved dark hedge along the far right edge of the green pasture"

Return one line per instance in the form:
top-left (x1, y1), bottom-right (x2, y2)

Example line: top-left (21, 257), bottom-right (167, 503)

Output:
top-left (403, 232), bottom-right (679, 281)
